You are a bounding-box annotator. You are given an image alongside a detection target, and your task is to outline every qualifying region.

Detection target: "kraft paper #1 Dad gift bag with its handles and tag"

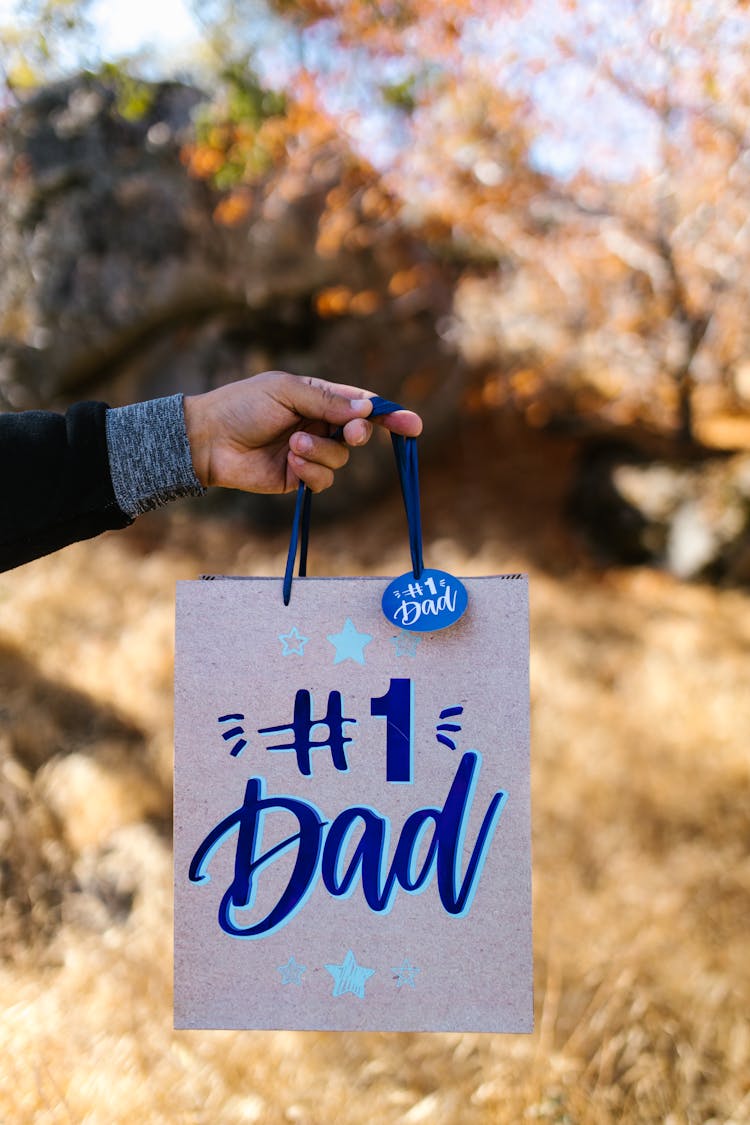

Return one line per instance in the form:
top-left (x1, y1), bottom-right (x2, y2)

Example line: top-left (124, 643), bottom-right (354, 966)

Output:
top-left (174, 400), bottom-right (532, 1032)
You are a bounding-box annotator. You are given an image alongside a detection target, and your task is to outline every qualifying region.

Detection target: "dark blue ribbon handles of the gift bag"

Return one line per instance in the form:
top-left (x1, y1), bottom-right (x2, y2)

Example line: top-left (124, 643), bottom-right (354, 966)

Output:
top-left (283, 395), bottom-right (424, 605)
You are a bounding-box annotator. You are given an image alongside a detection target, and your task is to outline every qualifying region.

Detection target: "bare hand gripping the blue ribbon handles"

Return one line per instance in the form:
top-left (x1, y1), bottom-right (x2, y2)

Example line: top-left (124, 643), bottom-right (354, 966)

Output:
top-left (184, 371), bottom-right (422, 493)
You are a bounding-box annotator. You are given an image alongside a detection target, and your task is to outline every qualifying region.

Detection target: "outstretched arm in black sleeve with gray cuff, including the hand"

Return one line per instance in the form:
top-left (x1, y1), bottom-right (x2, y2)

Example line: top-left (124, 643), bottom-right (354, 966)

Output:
top-left (0, 371), bottom-right (422, 570)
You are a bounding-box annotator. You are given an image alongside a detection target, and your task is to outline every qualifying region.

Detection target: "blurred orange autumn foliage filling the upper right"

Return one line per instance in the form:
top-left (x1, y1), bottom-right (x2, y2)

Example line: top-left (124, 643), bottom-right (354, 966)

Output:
top-left (190, 0), bottom-right (750, 438)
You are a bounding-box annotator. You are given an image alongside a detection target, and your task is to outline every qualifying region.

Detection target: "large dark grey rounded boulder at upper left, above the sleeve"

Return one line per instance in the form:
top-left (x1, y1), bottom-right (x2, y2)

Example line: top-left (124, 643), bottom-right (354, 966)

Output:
top-left (0, 77), bottom-right (225, 406)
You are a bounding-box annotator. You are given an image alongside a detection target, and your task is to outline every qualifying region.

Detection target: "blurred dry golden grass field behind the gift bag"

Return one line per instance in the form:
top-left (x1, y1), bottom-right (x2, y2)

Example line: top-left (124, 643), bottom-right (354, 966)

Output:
top-left (0, 422), bottom-right (750, 1125)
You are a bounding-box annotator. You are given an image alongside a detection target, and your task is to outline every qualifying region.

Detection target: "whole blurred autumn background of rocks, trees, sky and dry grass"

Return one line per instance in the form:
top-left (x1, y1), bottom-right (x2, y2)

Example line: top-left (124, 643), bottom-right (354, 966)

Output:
top-left (0, 0), bottom-right (750, 1125)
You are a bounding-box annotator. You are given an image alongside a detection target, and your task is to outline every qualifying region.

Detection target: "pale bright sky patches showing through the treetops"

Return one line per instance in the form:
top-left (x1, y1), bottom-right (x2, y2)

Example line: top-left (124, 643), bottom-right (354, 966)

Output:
top-left (0, 0), bottom-right (728, 180)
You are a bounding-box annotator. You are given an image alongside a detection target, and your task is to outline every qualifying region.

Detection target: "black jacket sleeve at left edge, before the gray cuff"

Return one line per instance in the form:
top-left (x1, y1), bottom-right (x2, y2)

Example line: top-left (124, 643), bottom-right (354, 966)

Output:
top-left (0, 403), bottom-right (133, 570)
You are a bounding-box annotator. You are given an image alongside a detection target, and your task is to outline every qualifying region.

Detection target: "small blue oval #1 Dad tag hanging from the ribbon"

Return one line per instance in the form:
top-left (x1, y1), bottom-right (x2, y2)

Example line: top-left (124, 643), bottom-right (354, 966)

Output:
top-left (382, 569), bottom-right (469, 632)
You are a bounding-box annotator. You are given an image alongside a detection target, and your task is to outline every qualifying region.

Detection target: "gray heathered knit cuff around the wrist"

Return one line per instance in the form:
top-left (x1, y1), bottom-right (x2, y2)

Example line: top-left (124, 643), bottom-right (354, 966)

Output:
top-left (107, 395), bottom-right (206, 516)
